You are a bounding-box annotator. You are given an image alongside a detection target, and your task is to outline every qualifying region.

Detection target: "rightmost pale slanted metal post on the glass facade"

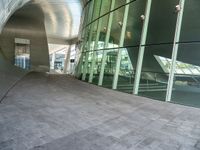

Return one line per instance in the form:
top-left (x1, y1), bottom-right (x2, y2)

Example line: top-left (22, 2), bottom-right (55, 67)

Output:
top-left (166, 0), bottom-right (185, 102)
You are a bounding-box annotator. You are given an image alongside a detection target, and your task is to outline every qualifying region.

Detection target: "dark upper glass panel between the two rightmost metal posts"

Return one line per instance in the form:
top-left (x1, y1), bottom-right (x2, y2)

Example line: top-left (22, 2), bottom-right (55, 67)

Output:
top-left (147, 0), bottom-right (179, 44)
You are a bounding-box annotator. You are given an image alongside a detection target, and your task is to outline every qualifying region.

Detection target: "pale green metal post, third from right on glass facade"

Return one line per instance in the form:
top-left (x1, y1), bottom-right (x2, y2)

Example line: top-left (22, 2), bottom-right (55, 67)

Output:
top-left (112, 0), bottom-right (130, 89)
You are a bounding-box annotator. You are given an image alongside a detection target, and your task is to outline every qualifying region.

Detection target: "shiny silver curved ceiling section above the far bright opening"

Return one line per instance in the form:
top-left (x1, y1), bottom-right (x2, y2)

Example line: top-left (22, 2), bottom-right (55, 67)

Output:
top-left (29, 0), bottom-right (82, 39)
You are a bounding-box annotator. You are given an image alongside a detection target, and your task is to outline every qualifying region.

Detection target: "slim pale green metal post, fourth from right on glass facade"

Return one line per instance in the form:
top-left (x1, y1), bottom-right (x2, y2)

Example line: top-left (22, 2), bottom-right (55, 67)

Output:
top-left (98, 0), bottom-right (115, 86)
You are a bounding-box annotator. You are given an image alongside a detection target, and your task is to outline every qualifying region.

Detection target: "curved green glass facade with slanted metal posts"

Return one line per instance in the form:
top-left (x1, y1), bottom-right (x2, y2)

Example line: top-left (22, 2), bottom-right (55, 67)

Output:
top-left (76, 0), bottom-right (200, 107)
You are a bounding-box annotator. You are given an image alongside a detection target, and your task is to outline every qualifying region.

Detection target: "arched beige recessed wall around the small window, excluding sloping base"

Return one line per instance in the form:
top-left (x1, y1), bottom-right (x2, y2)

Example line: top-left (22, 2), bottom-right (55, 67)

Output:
top-left (0, 5), bottom-right (49, 71)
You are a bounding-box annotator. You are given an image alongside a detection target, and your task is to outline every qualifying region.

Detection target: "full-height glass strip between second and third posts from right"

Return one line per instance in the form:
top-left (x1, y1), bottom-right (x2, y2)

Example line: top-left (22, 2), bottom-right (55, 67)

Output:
top-left (117, 0), bottom-right (146, 93)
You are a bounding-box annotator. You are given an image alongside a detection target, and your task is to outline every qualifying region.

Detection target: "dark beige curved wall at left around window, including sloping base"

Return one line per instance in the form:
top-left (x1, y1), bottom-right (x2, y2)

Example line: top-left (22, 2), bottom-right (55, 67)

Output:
top-left (0, 2), bottom-right (49, 99)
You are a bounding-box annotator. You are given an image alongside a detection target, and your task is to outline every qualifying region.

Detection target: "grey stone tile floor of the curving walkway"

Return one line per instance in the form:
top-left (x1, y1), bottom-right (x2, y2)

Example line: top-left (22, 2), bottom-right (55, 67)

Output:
top-left (0, 73), bottom-right (200, 150)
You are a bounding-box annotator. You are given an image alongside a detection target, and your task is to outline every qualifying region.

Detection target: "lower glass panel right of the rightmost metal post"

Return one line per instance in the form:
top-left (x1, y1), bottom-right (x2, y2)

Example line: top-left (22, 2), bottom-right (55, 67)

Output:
top-left (171, 43), bottom-right (200, 107)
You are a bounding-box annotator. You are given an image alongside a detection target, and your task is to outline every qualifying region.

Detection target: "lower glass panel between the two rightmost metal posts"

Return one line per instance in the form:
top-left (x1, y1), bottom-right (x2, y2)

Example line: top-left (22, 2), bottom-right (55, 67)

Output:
top-left (139, 44), bottom-right (173, 101)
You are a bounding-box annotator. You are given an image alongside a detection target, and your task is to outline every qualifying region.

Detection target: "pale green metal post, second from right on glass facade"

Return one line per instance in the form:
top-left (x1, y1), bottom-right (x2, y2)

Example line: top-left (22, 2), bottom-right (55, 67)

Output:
top-left (133, 0), bottom-right (152, 94)
